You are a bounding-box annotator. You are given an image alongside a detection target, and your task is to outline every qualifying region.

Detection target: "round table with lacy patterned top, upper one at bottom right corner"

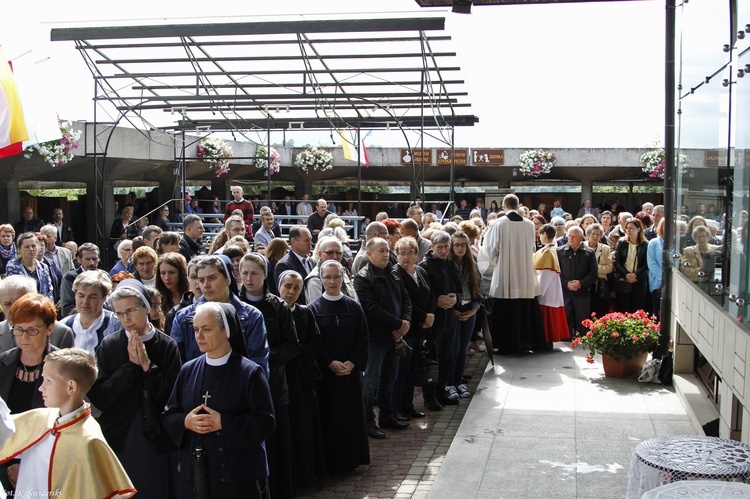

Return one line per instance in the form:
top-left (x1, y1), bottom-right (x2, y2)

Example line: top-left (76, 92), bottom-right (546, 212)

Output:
top-left (627, 435), bottom-right (750, 499)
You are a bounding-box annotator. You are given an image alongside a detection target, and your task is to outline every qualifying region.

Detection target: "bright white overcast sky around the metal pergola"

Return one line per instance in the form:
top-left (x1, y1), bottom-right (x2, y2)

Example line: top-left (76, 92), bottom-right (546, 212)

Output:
top-left (0, 0), bottom-right (664, 149)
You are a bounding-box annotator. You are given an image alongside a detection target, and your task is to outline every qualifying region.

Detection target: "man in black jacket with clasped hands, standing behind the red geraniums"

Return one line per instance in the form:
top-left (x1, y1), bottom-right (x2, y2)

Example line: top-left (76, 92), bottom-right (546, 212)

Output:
top-left (557, 226), bottom-right (599, 337)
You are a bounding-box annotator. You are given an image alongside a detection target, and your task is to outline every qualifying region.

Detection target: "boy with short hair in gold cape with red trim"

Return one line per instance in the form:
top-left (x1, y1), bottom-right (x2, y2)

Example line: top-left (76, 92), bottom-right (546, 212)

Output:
top-left (0, 348), bottom-right (136, 498)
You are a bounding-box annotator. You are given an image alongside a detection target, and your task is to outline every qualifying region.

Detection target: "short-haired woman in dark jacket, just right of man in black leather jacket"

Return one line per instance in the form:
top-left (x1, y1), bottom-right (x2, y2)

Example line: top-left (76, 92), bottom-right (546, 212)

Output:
top-left (391, 237), bottom-right (441, 421)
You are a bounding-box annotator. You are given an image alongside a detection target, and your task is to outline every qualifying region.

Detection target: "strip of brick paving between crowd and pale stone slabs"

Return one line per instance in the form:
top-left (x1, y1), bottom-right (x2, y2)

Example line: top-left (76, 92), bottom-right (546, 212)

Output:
top-left (297, 346), bottom-right (489, 499)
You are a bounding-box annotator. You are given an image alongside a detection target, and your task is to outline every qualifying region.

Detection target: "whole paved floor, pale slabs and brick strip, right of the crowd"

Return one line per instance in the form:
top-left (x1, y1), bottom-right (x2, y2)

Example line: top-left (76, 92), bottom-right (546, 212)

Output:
top-left (299, 343), bottom-right (695, 499)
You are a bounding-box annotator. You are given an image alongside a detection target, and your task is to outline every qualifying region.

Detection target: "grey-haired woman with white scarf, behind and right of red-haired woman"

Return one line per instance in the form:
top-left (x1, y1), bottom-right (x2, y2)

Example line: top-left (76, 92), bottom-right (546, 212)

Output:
top-left (62, 270), bottom-right (124, 355)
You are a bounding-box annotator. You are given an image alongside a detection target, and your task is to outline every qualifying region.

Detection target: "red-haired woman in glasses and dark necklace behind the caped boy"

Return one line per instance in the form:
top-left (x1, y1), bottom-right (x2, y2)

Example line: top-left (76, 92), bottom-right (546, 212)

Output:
top-left (0, 293), bottom-right (57, 491)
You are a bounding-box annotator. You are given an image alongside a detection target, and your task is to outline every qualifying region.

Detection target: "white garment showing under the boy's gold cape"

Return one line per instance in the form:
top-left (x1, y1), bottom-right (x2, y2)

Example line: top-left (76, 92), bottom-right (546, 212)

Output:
top-left (16, 404), bottom-right (84, 497)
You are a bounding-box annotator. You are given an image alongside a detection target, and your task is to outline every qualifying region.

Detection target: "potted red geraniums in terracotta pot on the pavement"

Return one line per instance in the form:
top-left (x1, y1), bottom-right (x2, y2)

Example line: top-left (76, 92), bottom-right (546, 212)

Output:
top-left (571, 310), bottom-right (659, 377)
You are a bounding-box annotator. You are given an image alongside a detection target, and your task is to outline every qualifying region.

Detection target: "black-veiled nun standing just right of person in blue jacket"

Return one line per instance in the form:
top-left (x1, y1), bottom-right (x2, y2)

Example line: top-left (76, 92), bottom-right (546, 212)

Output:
top-left (240, 253), bottom-right (302, 497)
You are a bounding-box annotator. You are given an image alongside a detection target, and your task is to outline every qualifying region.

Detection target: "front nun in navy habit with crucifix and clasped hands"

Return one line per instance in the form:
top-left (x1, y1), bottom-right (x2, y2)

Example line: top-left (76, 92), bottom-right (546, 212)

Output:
top-left (163, 302), bottom-right (274, 499)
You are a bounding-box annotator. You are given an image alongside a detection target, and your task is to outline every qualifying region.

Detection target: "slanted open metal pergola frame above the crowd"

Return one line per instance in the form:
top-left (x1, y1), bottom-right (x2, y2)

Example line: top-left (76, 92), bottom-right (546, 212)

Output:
top-left (51, 16), bottom-right (478, 254)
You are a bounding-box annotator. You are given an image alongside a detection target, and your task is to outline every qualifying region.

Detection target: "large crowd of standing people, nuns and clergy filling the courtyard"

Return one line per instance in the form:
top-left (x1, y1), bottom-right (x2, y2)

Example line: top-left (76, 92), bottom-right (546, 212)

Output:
top-left (0, 187), bottom-right (720, 498)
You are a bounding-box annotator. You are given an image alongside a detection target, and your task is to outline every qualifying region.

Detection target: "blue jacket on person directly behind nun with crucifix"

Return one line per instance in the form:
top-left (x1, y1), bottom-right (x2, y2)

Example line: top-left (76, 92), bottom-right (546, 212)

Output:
top-left (169, 294), bottom-right (268, 379)
